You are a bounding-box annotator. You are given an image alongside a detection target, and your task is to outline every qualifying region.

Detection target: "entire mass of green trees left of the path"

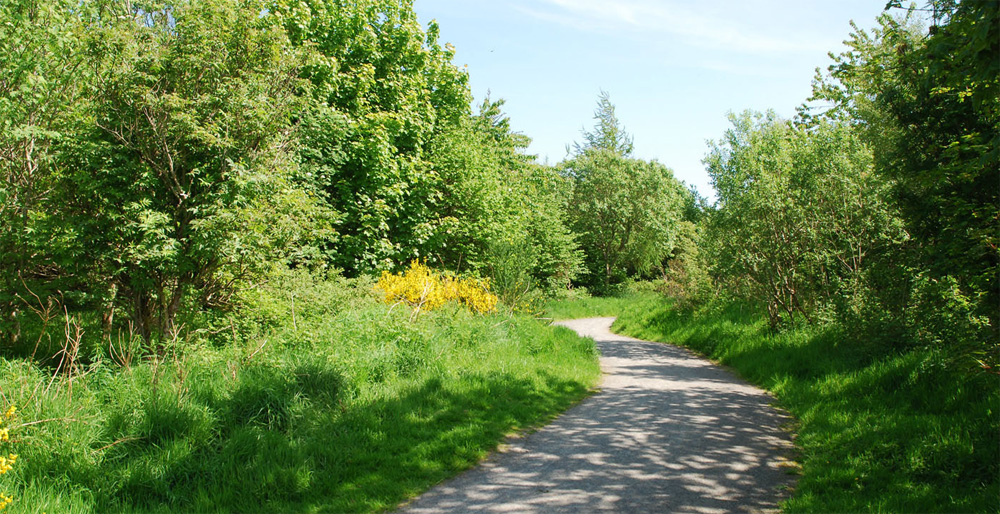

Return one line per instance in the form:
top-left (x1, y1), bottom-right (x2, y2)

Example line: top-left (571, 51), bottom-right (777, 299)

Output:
top-left (0, 0), bottom-right (582, 358)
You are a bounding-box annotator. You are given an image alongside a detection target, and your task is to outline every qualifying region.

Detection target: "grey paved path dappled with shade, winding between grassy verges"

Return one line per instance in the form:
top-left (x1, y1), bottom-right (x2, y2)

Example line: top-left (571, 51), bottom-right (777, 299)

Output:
top-left (400, 318), bottom-right (794, 514)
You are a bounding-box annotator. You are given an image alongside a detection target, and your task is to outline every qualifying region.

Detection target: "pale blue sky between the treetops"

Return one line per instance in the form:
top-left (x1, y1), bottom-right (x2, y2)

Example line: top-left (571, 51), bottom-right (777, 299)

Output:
top-left (414, 0), bottom-right (886, 199)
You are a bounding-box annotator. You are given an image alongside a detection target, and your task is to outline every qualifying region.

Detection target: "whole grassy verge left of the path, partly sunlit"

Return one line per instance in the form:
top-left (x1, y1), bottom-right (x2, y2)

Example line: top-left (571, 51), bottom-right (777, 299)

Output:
top-left (0, 270), bottom-right (599, 513)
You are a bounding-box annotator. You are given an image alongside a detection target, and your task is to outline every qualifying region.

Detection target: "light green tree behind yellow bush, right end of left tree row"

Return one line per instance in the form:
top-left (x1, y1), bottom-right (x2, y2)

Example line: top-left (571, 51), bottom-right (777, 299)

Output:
top-left (433, 98), bottom-right (582, 292)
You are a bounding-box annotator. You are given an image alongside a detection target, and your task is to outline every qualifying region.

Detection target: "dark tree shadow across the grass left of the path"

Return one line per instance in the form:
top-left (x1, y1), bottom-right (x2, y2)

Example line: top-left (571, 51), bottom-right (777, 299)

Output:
top-left (92, 358), bottom-right (588, 512)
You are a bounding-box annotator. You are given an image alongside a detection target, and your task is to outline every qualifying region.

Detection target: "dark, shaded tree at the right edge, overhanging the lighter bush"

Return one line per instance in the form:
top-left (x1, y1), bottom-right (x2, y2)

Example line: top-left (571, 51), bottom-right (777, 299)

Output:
top-left (813, 0), bottom-right (1000, 328)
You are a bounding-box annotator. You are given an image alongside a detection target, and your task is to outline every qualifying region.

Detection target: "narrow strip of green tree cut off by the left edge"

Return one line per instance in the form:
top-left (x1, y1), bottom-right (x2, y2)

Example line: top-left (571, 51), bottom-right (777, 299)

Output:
top-left (0, 0), bottom-right (87, 342)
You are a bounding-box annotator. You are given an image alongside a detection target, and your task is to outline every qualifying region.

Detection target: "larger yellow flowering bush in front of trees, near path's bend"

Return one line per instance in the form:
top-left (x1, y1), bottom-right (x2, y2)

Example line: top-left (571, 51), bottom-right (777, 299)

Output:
top-left (376, 260), bottom-right (498, 315)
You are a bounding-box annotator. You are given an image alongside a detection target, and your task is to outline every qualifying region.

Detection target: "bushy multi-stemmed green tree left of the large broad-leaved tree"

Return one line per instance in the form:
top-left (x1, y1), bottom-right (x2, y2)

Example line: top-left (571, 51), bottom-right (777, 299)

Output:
top-left (52, 0), bottom-right (307, 340)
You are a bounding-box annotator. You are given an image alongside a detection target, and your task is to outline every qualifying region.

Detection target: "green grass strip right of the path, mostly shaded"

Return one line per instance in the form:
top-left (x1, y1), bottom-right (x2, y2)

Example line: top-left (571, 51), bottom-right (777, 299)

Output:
top-left (560, 295), bottom-right (1000, 512)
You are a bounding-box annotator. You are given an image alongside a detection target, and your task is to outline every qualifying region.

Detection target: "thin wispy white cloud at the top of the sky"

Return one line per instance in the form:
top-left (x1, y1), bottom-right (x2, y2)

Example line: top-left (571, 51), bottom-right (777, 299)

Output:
top-left (520, 0), bottom-right (839, 54)
